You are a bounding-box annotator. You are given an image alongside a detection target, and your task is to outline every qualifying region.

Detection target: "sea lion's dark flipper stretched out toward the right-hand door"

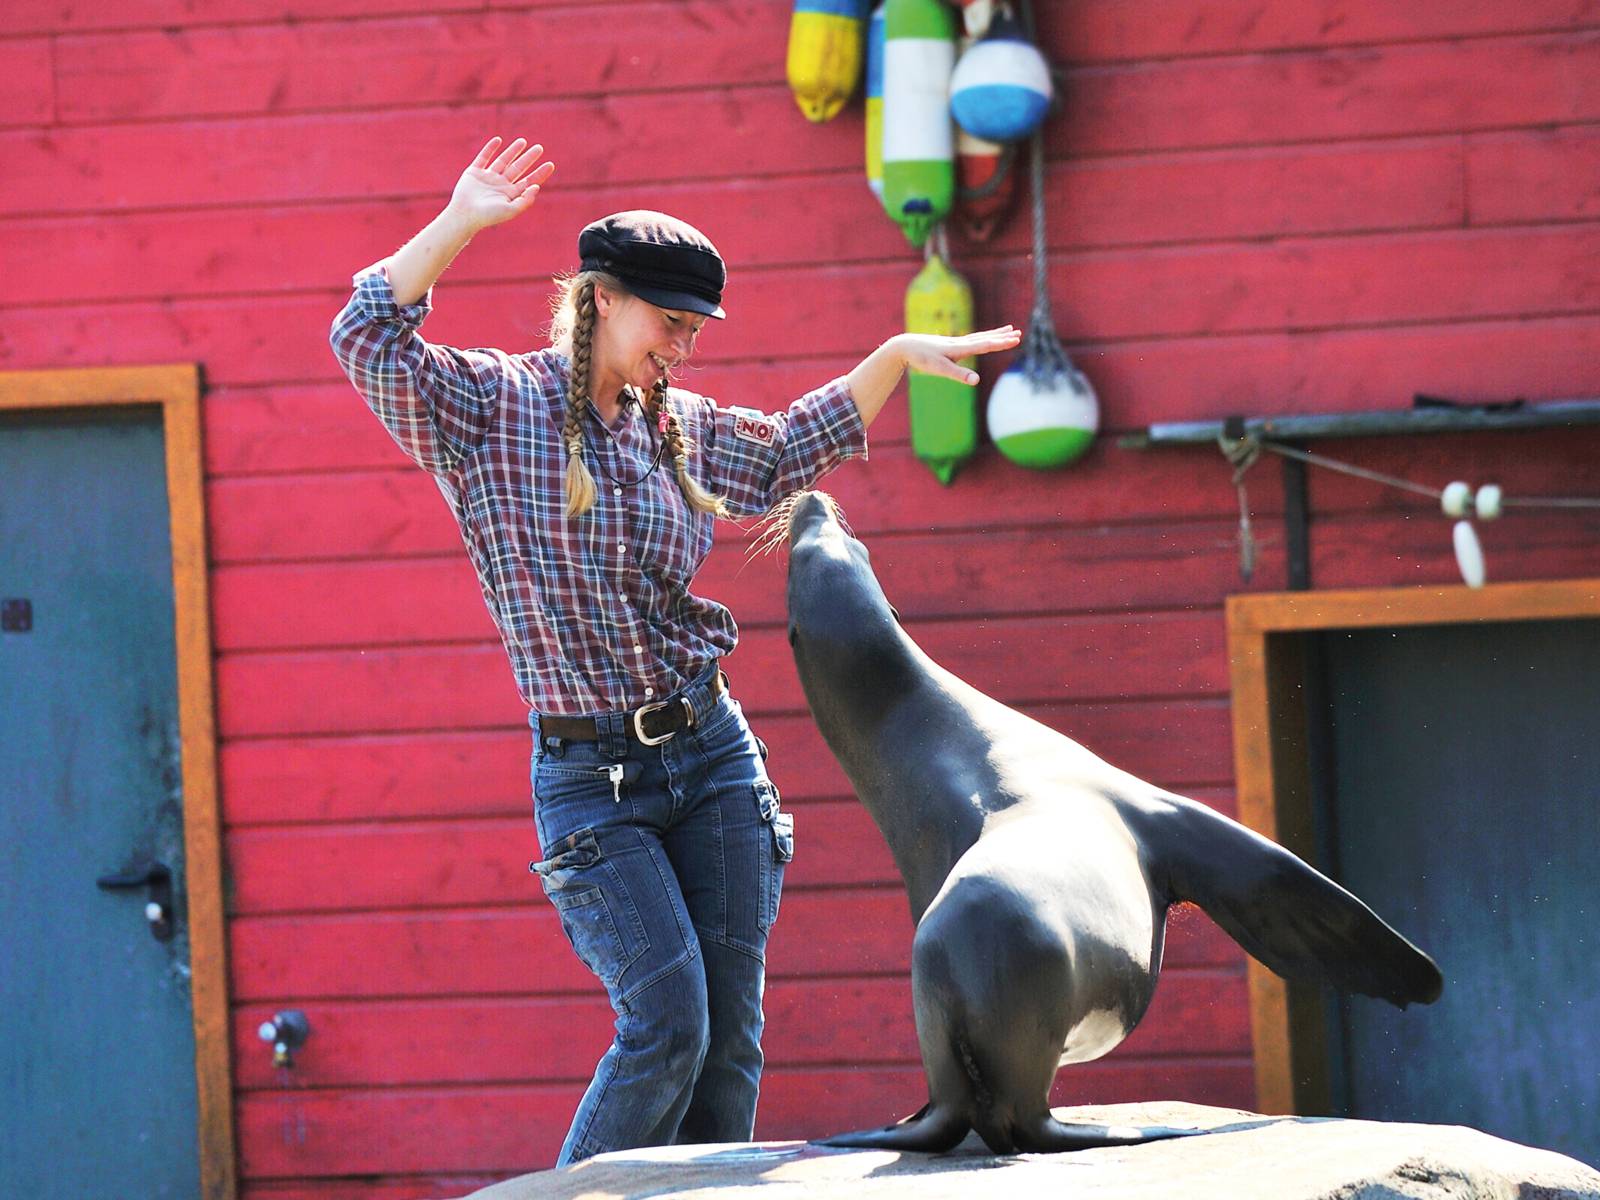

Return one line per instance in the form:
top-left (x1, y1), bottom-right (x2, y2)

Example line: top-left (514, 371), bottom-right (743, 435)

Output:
top-left (1158, 797), bottom-right (1443, 1008)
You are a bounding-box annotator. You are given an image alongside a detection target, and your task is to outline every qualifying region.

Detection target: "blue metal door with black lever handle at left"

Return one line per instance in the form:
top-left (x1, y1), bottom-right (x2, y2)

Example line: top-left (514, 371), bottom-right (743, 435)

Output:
top-left (0, 410), bottom-right (200, 1200)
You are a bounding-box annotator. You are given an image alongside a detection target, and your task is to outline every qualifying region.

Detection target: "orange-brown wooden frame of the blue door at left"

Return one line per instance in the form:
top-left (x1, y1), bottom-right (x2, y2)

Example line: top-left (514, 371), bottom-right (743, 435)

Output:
top-left (0, 363), bottom-right (238, 1200)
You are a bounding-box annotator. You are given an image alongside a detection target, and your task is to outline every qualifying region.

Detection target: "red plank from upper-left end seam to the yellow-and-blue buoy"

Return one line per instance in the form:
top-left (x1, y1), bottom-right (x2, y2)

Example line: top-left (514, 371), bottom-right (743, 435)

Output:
top-left (56, 0), bottom-right (789, 125)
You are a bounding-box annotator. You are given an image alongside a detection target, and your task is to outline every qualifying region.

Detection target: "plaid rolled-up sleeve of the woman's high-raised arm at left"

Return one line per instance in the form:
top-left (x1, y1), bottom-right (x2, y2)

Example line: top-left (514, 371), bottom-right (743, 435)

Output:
top-left (328, 262), bottom-right (504, 475)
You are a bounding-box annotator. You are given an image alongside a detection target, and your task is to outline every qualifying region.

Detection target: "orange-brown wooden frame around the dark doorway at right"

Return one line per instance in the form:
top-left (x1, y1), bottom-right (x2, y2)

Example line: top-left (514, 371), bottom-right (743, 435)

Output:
top-left (1227, 579), bottom-right (1600, 1114)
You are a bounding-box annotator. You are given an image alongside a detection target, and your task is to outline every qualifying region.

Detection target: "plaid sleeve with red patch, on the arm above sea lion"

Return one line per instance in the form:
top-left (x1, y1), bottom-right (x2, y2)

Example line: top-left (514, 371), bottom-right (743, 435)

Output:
top-left (698, 376), bottom-right (867, 517)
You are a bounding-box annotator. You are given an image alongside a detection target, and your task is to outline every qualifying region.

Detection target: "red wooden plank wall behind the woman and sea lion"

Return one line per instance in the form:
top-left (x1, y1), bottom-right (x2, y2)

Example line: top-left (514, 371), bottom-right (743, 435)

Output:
top-left (0, 0), bottom-right (1600, 1200)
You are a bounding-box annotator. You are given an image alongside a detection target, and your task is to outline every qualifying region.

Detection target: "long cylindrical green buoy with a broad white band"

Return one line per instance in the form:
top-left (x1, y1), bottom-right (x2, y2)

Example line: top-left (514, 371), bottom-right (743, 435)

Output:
top-left (883, 0), bottom-right (955, 246)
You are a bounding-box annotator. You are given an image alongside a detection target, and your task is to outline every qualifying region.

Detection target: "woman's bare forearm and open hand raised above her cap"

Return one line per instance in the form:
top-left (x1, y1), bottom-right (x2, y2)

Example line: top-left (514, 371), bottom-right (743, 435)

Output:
top-left (386, 138), bottom-right (555, 307)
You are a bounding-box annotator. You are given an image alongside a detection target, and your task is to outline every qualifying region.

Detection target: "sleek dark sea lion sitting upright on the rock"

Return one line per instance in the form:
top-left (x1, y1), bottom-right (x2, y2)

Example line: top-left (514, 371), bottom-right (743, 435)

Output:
top-left (770, 491), bottom-right (1443, 1154)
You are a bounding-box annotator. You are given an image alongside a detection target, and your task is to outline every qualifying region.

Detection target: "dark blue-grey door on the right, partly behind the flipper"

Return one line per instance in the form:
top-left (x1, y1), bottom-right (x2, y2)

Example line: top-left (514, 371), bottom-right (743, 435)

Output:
top-left (1323, 621), bottom-right (1600, 1163)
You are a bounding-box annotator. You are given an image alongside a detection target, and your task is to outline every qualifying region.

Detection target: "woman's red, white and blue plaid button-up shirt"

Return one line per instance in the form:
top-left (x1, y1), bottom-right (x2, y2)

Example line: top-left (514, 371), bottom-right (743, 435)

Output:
top-left (331, 264), bottom-right (867, 715)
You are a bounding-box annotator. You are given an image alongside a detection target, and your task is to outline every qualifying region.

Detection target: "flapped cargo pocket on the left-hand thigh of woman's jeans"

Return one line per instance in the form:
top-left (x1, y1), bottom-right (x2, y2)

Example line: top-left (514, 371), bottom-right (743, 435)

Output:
top-left (528, 829), bottom-right (650, 990)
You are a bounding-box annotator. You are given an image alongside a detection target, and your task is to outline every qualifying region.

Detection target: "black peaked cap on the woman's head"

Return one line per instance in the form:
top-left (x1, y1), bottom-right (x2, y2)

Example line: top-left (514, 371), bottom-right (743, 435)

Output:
top-left (578, 208), bottom-right (728, 317)
